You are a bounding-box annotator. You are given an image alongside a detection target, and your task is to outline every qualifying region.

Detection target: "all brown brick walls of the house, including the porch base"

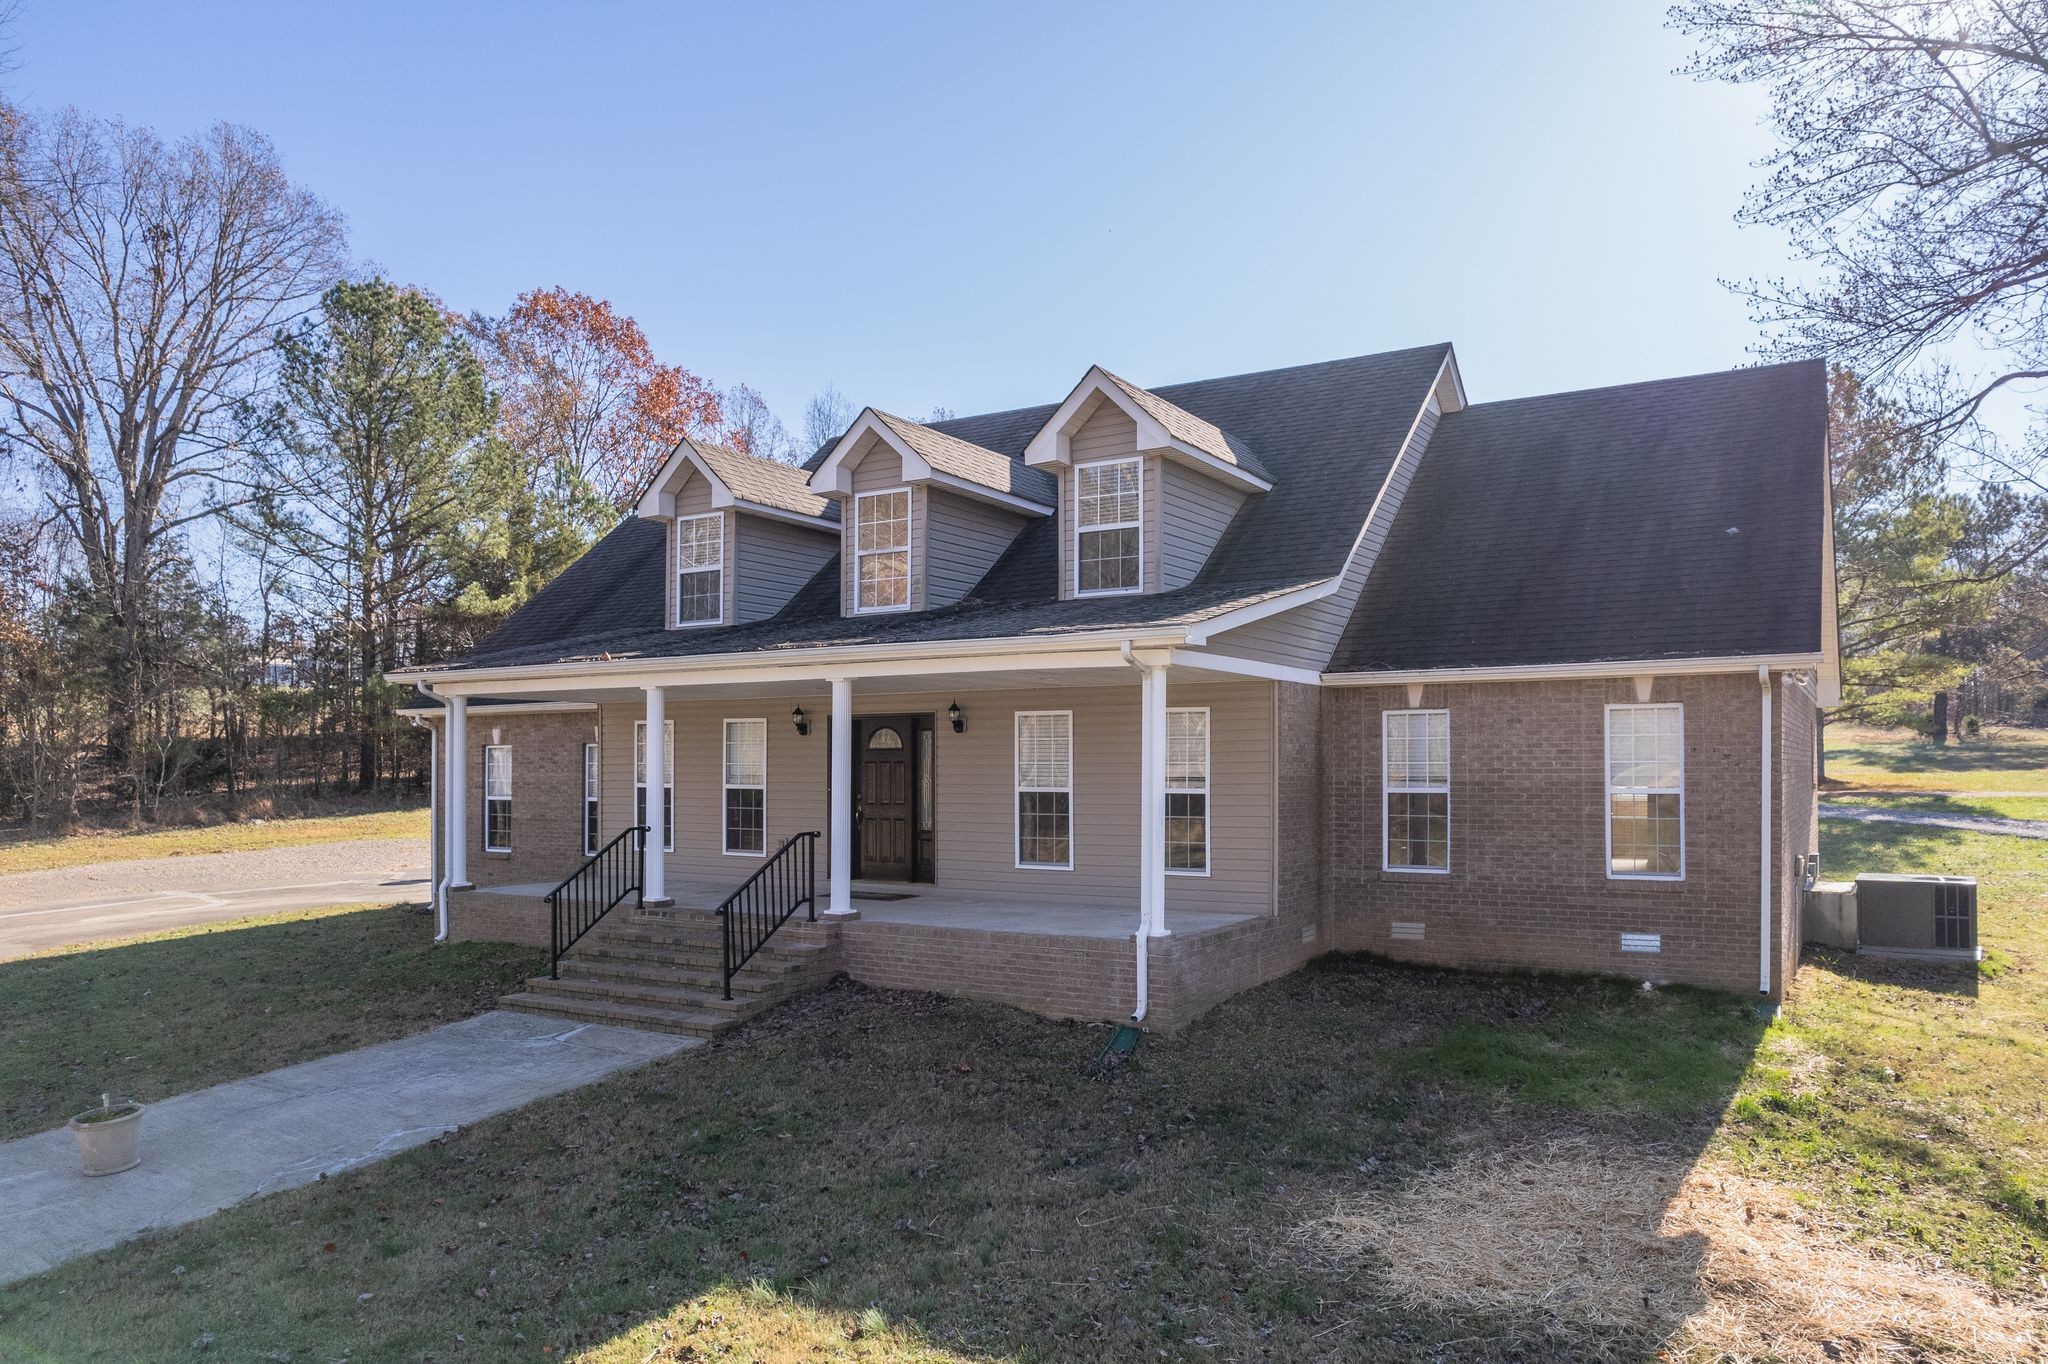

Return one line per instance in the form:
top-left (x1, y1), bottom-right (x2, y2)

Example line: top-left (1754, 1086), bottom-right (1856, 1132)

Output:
top-left (423, 674), bottom-right (1817, 1030)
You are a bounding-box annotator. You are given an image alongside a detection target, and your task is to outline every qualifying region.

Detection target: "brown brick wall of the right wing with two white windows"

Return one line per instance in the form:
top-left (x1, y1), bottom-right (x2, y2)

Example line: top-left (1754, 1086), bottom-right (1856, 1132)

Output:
top-left (1323, 674), bottom-right (1812, 993)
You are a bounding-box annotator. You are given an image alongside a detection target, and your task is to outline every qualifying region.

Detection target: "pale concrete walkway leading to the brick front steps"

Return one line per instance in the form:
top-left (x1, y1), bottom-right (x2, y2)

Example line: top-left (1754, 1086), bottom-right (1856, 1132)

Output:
top-left (0, 1010), bottom-right (702, 1284)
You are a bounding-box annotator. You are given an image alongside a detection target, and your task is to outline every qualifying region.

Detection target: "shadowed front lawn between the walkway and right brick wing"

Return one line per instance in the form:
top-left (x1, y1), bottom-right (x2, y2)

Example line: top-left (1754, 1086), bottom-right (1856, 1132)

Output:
top-left (0, 958), bottom-right (1761, 1364)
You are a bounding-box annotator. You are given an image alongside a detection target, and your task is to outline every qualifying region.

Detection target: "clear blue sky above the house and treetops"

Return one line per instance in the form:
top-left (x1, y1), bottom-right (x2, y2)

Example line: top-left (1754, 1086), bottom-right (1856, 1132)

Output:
top-left (12, 0), bottom-right (1788, 430)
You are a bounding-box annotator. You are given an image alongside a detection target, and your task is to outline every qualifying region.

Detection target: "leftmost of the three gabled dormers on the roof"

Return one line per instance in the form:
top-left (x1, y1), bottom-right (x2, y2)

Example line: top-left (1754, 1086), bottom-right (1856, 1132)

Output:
top-left (637, 438), bottom-right (840, 631)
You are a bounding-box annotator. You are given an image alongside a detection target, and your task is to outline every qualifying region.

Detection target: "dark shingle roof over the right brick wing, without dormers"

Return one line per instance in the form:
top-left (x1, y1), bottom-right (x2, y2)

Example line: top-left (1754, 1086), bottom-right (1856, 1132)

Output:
top-left (1329, 360), bottom-right (1827, 672)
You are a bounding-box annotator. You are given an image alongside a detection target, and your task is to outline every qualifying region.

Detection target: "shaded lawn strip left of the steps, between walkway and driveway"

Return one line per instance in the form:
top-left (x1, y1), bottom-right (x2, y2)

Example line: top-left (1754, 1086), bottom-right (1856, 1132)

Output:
top-left (0, 905), bottom-right (543, 1138)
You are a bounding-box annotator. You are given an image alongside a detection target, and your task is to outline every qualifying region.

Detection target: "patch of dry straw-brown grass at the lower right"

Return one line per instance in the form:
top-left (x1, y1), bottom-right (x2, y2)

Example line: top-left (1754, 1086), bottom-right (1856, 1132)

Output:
top-left (1300, 1143), bottom-right (2048, 1364)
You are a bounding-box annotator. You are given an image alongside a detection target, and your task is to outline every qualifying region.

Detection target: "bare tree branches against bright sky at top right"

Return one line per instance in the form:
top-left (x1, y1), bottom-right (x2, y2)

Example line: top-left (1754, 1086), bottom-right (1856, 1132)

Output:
top-left (1671, 0), bottom-right (2048, 465)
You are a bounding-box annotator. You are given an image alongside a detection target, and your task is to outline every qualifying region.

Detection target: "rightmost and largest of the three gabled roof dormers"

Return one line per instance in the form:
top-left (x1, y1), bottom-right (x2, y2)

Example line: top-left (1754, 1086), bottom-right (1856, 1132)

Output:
top-left (1024, 365), bottom-right (1272, 598)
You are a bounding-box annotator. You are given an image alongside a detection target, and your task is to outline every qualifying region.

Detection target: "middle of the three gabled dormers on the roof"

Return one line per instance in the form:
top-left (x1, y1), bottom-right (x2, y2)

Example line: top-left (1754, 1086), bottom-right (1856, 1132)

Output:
top-left (811, 408), bottom-right (1055, 616)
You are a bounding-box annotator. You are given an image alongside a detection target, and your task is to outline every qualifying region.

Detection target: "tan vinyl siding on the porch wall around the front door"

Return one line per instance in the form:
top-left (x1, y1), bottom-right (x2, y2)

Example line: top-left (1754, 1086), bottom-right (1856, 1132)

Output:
top-left (585, 674), bottom-right (1276, 913)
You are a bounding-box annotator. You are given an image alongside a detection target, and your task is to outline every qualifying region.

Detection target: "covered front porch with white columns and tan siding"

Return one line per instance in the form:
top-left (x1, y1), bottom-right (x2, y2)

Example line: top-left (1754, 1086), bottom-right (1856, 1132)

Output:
top-left (413, 647), bottom-right (1315, 1018)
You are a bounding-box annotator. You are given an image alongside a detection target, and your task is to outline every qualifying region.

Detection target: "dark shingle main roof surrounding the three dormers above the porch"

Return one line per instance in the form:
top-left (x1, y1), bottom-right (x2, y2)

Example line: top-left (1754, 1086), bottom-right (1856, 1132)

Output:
top-left (448, 344), bottom-right (1450, 668)
